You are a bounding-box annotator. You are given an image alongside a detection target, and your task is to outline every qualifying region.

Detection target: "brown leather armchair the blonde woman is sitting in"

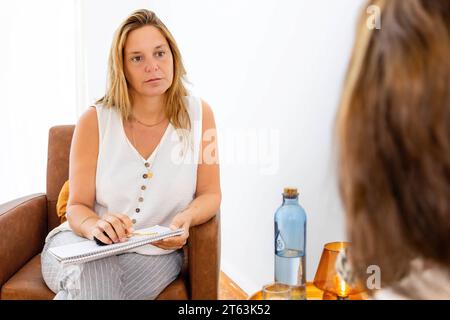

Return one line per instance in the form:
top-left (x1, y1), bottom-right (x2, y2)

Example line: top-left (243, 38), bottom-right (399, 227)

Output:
top-left (0, 125), bottom-right (220, 300)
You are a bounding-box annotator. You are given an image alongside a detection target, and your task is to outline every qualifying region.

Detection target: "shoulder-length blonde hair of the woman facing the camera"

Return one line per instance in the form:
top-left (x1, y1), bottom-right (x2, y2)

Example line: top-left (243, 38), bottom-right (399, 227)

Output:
top-left (96, 9), bottom-right (191, 130)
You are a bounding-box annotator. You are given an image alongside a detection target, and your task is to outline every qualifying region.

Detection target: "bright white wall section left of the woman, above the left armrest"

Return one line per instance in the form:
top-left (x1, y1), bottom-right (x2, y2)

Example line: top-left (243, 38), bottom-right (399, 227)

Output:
top-left (0, 0), bottom-right (77, 203)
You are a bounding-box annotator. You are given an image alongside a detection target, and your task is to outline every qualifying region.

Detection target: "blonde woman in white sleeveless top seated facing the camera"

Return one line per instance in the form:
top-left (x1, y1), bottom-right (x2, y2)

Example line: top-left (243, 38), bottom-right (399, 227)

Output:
top-left (42, 10), bottom-right (221, 299)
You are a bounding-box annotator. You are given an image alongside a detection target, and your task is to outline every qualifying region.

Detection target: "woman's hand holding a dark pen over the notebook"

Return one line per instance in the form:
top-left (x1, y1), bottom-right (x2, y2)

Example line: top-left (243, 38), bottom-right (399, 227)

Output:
top-left (88, 213), bottom-right (133, 244)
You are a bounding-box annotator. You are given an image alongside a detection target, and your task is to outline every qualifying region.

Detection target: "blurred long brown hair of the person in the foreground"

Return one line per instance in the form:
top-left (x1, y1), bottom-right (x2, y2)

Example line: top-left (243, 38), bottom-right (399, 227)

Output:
top-left (337, 0), bottom-right (450, 294)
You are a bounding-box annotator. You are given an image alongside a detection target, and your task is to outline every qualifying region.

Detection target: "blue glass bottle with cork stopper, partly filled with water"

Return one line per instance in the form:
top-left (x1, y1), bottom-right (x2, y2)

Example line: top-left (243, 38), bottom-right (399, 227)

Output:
top-left (275, 188), bottom-right (306, 300)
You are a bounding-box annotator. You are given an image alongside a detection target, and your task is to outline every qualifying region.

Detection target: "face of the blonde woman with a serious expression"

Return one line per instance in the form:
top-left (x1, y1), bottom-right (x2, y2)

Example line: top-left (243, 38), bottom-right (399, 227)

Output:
top-left (124, 26), bottom-right (173, 97)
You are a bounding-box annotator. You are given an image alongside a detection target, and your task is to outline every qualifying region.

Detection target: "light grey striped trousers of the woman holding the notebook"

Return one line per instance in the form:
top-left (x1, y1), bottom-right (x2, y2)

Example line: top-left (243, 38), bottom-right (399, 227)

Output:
top-left (41, 231), bottom-right (183, 300)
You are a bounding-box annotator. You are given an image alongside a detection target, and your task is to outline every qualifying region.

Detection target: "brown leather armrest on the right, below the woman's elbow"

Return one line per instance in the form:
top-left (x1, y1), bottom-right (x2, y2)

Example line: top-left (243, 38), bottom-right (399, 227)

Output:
top-left (188, 211), bottom-right (220, 300)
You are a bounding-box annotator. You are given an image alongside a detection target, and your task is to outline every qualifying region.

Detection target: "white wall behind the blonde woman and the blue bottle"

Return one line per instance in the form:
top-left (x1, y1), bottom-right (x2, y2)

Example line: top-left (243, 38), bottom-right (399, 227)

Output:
top-left (84, 0), bottom-right (362, 294)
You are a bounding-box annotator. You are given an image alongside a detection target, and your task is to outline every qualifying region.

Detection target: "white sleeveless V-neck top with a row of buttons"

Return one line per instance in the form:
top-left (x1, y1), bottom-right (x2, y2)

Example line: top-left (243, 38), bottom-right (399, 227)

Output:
top-left (46, 96), bottom-right (202, 255)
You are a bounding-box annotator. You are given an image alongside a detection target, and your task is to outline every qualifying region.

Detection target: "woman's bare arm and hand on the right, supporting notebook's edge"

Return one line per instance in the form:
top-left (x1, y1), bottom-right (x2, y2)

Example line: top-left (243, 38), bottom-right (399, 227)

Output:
top-left (153, 101), bottom-right (222, 249)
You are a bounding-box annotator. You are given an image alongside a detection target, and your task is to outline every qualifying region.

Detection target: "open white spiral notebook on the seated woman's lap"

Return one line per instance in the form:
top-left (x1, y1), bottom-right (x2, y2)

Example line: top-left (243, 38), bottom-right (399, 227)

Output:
top-left (48, 225), bottom-right (184, 265)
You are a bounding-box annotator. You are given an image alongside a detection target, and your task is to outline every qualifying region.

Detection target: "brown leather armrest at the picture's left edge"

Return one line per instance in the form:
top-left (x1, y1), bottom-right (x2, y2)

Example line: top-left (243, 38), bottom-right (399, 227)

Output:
top-left (0, 193), bottom-right (47, 288)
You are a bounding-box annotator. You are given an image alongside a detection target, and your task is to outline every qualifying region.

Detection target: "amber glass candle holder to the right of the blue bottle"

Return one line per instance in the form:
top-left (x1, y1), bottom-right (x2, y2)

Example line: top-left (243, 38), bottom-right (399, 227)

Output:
top-left (314, 242), bottom-right (364, 300)
